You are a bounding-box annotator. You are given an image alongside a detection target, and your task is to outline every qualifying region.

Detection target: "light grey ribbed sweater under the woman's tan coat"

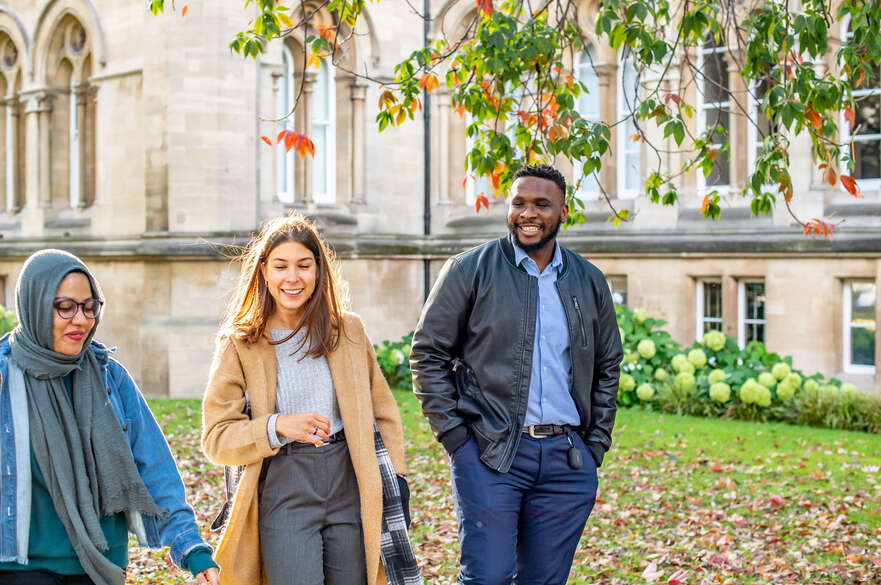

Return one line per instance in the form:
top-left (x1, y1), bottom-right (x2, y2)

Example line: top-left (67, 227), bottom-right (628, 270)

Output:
top-left (266, 329), bottom-right (343, 448)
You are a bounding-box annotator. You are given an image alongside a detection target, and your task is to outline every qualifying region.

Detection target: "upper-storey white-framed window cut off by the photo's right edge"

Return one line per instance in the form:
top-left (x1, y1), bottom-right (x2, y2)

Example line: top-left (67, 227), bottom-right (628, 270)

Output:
top-left (841, 19), bottom-right (881, 188)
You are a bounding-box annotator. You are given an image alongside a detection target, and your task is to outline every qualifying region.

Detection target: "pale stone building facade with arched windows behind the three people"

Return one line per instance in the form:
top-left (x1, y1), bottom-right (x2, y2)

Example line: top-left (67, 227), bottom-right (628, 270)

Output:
top-left (0, 0), bottom-right (881, 396)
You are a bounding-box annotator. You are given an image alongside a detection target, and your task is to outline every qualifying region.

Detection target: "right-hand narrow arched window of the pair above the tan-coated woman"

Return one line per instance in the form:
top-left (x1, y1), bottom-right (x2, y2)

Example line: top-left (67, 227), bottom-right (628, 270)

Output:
top-left (312, 59), bottom-right (336, 204)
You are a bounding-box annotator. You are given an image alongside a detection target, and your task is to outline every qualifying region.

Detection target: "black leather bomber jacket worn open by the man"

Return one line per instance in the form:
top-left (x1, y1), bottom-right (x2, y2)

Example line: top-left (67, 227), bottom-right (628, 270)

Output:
top-left (410, 237), bottom-right (622, 472)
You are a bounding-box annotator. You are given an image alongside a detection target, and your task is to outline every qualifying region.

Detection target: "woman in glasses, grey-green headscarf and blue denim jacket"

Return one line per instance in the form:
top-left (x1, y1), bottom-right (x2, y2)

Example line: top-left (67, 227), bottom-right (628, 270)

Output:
top-left (0, 250), bottom-right (219, 585)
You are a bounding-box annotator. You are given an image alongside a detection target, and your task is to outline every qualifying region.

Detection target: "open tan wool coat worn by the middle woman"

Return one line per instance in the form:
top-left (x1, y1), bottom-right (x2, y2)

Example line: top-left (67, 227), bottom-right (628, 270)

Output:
top-left (202, 313), bottom-right (406, 585)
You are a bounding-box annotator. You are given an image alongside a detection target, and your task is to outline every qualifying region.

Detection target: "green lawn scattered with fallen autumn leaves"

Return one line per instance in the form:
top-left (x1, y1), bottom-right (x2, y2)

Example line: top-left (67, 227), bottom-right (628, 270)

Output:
top-left (129, 392), bottom-right (881, 585)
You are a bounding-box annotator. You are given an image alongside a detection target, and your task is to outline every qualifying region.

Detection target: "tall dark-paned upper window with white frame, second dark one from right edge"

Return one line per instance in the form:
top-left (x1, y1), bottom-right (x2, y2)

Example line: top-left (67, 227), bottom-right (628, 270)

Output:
top-left (697, 40), bottom-right (731, 195)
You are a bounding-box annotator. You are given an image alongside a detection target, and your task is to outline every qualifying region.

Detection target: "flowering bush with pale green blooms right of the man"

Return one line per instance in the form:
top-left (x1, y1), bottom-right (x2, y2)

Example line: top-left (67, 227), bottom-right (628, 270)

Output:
top-left (616, 307), bottom-right (881, 433)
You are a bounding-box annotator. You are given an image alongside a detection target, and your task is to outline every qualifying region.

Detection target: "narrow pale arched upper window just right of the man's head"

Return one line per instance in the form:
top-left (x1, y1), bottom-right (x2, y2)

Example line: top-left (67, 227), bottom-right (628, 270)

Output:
top-left (617, 49), bottom-right (642, 199)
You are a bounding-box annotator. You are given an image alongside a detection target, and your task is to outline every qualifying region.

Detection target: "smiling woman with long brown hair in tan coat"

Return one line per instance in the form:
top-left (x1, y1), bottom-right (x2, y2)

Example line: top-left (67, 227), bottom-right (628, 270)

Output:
top-left (202, 214), bottom-right (406, 585)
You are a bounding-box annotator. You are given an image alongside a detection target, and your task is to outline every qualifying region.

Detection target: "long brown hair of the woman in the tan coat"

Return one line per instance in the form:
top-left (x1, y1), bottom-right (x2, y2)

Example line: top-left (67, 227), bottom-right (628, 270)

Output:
top-left (220, 211), bottom-right (348, 357)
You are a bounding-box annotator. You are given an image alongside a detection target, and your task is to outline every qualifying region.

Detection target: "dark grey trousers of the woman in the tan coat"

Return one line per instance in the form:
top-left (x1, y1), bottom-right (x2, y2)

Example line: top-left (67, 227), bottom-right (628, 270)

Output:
top-left (259, 441), bottom-right (367, 585)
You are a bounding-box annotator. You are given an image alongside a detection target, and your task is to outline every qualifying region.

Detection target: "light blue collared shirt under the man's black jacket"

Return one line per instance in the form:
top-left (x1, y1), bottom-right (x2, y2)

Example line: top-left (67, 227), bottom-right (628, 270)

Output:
top-left (514, 237), bottom-right (580, 426)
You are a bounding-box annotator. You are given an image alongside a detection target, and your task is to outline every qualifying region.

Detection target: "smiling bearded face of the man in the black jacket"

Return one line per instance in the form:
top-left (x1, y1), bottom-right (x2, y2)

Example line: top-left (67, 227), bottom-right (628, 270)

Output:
top-left (508, 177), bottom-right (569, 252)
